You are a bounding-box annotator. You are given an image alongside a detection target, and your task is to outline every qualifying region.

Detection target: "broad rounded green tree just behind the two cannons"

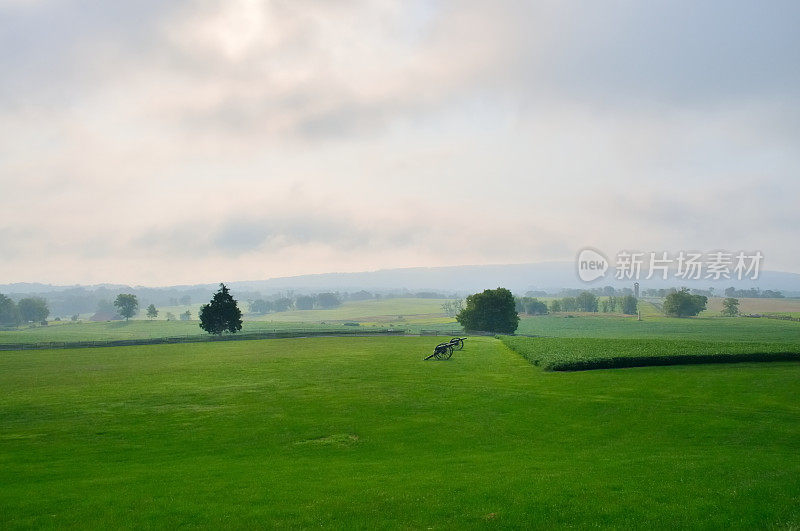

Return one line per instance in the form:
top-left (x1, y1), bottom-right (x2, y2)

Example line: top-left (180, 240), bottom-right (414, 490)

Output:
top-left (456, 288), bottom-right (519, 334)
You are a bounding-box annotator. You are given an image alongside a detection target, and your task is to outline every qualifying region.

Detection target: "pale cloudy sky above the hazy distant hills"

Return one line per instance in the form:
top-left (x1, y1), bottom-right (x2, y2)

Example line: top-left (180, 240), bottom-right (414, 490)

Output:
top-left (0, 0), bottom-right (800, 286)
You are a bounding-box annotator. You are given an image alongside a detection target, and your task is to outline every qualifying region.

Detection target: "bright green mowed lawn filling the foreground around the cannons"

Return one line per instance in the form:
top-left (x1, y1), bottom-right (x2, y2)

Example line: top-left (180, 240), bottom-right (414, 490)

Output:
top-left (0, 337), bottom-right (800, 529)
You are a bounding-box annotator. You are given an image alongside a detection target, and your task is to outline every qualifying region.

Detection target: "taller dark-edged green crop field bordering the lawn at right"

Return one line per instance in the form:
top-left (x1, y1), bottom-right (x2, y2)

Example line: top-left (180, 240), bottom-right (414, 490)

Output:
top-left (501, 336), bottom-right (800, 371)
